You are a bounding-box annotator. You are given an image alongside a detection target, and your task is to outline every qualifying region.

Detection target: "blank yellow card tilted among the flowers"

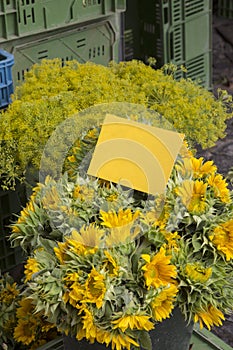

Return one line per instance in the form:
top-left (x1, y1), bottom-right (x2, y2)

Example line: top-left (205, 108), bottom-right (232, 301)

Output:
top-left (87, 114), bottom-right (184, 195)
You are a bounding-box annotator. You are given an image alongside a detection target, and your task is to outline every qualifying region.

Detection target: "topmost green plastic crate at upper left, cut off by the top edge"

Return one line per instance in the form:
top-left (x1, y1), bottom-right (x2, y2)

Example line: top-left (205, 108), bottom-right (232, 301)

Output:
top-left (0, 0), bottom-right (126, 42)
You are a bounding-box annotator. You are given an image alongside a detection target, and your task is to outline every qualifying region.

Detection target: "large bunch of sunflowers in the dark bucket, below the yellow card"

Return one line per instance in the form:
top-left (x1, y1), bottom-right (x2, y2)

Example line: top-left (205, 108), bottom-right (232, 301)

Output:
top-left (11, 136), bottom-right (233, 350)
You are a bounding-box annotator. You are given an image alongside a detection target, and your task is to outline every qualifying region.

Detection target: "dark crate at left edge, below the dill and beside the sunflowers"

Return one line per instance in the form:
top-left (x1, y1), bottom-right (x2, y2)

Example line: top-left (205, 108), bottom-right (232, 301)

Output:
top-left (0, 186), bottom-right (26, 273)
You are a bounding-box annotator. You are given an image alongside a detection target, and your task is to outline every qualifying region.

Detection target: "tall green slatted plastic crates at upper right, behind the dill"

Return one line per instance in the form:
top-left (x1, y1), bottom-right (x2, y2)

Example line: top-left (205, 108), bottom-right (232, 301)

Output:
top-left (139, 0), bottom-right (212, 88)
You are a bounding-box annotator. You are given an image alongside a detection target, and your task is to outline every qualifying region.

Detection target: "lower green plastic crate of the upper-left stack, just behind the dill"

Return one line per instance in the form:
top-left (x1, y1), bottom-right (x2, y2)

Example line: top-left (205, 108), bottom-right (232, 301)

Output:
top-left (0, 14), bottom-right (122, 85)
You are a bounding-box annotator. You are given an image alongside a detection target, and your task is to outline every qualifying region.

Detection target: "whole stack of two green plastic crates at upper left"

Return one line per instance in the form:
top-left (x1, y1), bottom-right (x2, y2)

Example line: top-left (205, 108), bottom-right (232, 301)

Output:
top-left (0, 0), bottom-right (126, 85)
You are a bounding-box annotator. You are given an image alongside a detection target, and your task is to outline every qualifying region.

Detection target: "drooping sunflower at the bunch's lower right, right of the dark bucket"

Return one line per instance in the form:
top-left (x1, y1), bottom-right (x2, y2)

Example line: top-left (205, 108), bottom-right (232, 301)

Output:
top-left (194, 305), bottom-right (225, 330)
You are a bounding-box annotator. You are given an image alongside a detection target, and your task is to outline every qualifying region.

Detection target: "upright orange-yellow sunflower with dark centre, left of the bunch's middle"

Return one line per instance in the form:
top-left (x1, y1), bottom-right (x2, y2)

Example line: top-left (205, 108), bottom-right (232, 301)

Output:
top-left (85, 268), bottom-right (106, 309)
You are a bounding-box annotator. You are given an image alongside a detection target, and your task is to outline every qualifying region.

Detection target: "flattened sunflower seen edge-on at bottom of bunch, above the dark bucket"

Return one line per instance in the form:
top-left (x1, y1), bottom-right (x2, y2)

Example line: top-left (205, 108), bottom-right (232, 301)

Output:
top-left (112, 315), bottom-right (154, 333)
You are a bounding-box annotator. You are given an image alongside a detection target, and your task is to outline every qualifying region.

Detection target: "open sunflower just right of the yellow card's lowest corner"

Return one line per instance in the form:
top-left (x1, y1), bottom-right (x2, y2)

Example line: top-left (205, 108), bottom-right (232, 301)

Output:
top-left (176, 180), bottom-right (208, 214)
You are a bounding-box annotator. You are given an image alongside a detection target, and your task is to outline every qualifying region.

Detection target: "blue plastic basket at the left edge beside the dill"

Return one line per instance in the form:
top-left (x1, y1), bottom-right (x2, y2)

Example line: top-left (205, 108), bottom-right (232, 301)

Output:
top-left (0, 50), bottom-right (14, 108)
